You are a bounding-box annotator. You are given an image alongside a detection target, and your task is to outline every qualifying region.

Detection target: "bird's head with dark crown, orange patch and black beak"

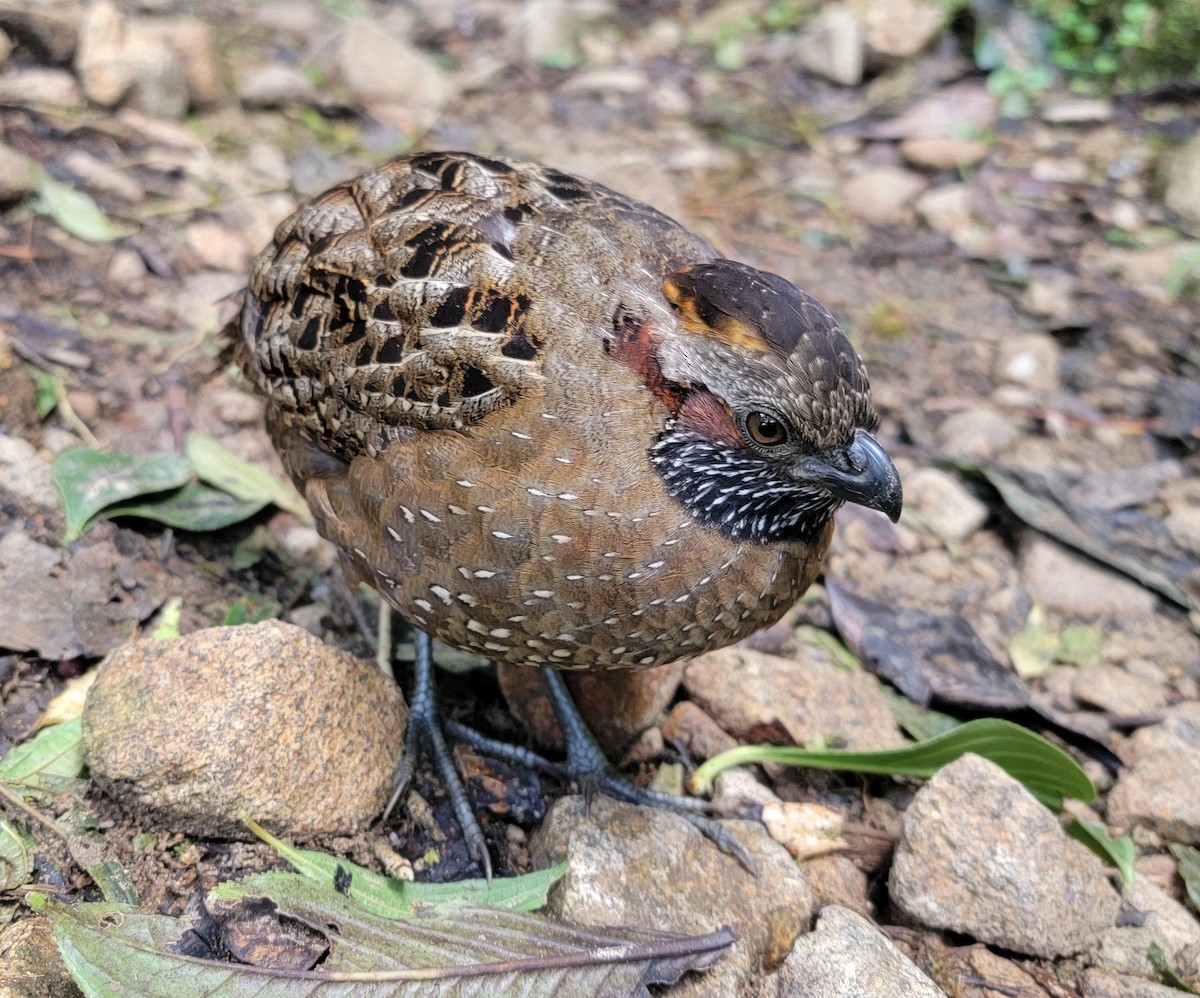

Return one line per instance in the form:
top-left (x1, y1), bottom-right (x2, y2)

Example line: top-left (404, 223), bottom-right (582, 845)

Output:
top-left (650, 260), bottom-right (902, 543)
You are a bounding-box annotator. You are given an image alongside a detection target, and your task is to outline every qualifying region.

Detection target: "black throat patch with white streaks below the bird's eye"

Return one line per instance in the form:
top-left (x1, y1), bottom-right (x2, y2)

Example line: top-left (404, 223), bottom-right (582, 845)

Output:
top-left (650, 429), bottom-right (841, 543)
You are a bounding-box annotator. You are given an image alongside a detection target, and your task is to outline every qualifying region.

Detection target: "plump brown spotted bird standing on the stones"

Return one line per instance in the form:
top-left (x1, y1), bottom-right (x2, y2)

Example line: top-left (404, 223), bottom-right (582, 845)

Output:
top-left (226, 151), bottom-right (902, 878)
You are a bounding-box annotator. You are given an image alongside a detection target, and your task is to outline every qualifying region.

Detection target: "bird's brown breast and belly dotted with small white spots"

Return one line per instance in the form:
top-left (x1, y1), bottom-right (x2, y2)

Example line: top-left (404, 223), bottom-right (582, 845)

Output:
top-left (305, 371), bottom-right (824, 668)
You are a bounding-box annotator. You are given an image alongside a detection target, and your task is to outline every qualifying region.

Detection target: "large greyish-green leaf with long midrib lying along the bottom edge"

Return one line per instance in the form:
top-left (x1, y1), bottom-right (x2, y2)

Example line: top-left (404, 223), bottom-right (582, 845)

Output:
top-left (39, 873), bottom-right (737, 998)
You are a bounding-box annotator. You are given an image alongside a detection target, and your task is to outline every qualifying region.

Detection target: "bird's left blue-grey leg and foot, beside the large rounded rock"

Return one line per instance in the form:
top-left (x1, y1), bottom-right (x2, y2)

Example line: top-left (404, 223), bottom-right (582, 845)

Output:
top-left (384, 631), bottom-right (492, 883)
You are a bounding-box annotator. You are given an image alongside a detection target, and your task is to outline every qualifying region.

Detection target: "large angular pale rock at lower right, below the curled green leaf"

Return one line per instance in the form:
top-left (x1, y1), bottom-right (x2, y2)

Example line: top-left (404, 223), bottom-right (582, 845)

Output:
top-left (889, 756), bottom-right (1121, 957)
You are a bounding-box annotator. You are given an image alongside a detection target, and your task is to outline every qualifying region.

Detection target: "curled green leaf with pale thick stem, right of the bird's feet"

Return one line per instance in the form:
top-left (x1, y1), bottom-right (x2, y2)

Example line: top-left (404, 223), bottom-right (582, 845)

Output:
top-left (692, 717), bottom-right (1096, 810)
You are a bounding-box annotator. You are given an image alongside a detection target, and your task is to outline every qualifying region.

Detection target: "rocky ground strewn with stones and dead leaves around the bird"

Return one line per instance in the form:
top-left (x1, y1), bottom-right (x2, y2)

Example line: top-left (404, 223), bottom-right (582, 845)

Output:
top-left (0, 0), bottom-right (1200, 998)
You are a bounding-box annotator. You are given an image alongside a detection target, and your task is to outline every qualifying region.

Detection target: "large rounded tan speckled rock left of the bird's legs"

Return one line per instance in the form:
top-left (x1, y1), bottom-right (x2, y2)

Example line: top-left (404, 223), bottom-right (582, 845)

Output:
top-left (83, 620), bottom-right (408, 838)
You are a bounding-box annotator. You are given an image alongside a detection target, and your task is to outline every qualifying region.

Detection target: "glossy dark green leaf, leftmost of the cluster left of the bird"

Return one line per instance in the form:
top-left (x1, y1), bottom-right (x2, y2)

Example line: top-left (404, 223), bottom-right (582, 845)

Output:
top-left (52, 447), bottom-right (187, 543)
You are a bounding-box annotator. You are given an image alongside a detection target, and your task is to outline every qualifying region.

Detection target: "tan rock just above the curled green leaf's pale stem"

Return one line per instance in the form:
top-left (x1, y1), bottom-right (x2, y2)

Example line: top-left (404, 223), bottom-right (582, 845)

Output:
top-left (684, 645), bottom-right (904, 750)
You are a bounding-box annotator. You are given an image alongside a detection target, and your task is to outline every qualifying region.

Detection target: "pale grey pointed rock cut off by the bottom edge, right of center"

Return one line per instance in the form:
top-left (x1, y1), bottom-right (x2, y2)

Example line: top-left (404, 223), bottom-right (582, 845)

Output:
top-left (779, 906), bottom-right (943, 998)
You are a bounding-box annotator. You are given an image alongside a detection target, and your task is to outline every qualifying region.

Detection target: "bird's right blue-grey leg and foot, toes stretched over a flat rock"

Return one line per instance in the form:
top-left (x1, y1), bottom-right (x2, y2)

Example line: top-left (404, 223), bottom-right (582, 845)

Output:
top-left (541, 669), bottom-right (757, 873)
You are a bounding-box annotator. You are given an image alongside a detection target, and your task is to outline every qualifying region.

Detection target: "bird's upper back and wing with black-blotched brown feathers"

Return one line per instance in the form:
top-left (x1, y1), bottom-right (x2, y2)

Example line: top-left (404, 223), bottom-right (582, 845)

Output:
top-left (241, 152), bottom-right (716, 453)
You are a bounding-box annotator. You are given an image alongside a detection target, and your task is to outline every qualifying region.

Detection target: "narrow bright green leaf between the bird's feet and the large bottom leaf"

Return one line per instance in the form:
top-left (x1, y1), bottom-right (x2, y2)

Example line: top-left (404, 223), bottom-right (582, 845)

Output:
top-left (244, 818), bottom-right (566, 919)
